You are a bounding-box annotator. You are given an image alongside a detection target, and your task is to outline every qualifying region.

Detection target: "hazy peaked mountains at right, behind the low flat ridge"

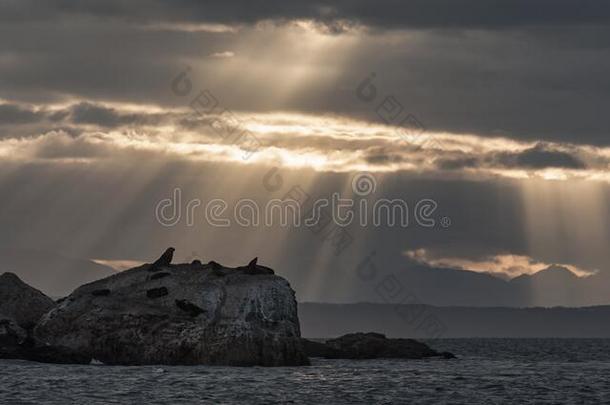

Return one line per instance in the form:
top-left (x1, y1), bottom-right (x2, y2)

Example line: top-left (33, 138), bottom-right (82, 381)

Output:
top-left (363, 264), bottom-right (610, 307)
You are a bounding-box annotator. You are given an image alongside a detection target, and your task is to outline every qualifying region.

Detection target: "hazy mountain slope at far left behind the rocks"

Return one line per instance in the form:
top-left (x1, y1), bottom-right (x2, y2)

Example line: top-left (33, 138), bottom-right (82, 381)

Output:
top-left (0, 249), bottom-right (116, 298)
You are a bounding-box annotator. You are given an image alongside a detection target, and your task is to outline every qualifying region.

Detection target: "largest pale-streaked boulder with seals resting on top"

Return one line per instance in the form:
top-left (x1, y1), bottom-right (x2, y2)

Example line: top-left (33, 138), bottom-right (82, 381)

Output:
top-left (35, 263), bottom-right (309, 366)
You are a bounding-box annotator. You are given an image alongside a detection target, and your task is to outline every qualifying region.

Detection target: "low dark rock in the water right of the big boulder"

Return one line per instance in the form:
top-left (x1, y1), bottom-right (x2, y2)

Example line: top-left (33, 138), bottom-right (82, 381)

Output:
top-left (303, 332), bottom-right (454, 359)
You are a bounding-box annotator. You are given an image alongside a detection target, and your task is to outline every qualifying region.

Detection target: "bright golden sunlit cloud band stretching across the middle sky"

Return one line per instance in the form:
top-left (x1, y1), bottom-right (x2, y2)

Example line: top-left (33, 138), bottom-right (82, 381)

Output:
top-left (0, 100), bottom-right (610, 183)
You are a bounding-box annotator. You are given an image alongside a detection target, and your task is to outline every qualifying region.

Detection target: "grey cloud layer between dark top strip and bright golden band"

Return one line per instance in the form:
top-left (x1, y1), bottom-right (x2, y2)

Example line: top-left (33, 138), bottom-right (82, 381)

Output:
top-left (0, 13), bottom-right (610, 145)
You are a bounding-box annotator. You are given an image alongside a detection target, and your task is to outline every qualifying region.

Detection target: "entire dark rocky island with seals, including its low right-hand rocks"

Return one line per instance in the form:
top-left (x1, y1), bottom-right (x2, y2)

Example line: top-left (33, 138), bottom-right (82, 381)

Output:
top-left (0, 248), bottom-right (452, 366)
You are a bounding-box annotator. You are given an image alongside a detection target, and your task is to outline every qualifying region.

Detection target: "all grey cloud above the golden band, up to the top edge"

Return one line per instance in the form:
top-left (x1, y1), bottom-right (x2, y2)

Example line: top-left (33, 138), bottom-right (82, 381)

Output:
top-left (0, 0), bottom-right (610, 145)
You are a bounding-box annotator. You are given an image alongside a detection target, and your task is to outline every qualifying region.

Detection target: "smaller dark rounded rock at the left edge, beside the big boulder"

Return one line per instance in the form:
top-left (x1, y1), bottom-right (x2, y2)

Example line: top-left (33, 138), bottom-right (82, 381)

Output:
top-left (0, 273), bottom-right (55, 329)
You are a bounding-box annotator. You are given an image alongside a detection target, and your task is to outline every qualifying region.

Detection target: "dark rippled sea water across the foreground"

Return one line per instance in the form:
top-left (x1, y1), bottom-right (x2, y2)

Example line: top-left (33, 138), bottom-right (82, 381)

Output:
top-left (0, 339), bottom-right (610, 405)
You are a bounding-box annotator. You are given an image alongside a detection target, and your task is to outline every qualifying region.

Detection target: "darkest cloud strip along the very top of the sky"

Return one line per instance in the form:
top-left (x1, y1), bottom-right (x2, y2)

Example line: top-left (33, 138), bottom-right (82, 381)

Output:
top-left (0, 0), bottom-right (610, 30)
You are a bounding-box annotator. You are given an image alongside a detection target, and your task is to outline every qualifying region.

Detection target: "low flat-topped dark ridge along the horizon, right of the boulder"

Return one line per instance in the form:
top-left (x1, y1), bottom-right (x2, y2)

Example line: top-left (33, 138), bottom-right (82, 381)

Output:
top-left (299, 303), bottom-right (610, 339)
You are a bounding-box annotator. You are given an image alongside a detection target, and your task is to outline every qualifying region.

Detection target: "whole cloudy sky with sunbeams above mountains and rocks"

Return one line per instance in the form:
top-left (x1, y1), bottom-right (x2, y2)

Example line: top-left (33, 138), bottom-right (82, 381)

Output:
top-left (0, 0), bottom-right (610, 302)
